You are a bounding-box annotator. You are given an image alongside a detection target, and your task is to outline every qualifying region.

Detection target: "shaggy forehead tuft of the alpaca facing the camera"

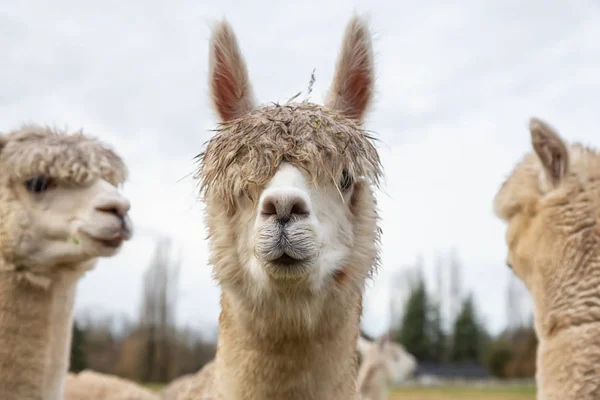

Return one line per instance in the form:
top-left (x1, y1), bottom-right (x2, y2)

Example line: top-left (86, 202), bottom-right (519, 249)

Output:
top-left (196, 102), bottom-right (382, 211)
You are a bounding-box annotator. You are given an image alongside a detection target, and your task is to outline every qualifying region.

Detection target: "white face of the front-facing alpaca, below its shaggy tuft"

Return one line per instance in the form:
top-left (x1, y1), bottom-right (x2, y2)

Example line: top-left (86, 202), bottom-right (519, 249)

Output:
top-left (246, 163), bottom-right (358, 291)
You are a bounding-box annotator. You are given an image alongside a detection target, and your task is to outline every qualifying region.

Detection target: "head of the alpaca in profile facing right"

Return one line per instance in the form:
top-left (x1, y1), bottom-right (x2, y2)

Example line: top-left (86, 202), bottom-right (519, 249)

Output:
top-left (0, 126), bottom-right (132, 284)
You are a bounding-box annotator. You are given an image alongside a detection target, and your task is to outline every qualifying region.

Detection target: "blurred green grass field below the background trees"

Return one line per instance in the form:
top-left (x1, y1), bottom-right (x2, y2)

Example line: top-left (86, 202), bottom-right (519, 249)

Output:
top-left (145, 384), bottom-right (535, 400)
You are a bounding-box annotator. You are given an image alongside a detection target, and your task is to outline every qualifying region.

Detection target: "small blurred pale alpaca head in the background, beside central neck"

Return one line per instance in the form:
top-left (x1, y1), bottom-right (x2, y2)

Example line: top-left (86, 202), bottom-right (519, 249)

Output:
top-left (358, 335), bottom-right (417, 384)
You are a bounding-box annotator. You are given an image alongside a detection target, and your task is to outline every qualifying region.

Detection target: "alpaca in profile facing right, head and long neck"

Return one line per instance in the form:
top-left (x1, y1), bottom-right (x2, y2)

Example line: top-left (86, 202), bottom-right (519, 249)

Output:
top-left (0, 125), bottom-right (133, 400)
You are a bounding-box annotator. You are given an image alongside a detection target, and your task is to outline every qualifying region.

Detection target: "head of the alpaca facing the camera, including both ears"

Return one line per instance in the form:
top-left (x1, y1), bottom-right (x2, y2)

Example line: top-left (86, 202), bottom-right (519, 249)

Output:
top-left (197, 18), bottom-right (381, 318)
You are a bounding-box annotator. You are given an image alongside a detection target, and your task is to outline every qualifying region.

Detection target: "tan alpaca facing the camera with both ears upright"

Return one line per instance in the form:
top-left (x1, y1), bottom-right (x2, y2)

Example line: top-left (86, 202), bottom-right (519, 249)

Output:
top-left (170, 17), bottom-right (381, 400)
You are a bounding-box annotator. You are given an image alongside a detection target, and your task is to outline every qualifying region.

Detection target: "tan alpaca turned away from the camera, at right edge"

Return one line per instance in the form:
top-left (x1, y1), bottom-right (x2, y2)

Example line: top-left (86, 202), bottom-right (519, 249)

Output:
top-left (494, 118), bottom-right (600, 400)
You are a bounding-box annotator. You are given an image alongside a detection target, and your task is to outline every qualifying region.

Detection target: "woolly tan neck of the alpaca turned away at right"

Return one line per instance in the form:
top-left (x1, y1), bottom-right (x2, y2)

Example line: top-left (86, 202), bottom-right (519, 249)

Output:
top-left (533, 253), bottom-right (600, 400)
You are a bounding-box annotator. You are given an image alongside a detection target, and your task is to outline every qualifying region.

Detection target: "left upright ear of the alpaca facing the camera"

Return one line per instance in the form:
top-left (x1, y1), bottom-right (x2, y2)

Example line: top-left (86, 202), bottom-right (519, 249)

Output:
top-left (208, 21), bottom-right (255, 122)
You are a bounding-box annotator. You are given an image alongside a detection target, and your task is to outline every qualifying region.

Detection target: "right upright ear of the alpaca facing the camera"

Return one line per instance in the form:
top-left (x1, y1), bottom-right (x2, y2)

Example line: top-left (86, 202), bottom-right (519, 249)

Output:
top-left (325, 16), bottom-right (375, 122)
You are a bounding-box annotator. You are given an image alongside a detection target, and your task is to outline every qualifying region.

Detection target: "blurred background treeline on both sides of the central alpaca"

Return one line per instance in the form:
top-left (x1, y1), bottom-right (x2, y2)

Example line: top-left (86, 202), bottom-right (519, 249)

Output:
top-left (70, 238), bottom-right (537, 383)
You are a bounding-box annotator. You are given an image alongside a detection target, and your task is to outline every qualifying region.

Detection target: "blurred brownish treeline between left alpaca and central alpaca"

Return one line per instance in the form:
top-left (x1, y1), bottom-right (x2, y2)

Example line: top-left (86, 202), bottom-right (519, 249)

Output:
top-left (70, 238), bottom-right (216, 383)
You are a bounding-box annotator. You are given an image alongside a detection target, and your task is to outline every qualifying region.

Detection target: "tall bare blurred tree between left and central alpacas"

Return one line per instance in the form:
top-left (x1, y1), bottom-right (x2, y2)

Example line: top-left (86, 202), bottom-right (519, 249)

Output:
top-left (139, 237), bottom-right (181, 382)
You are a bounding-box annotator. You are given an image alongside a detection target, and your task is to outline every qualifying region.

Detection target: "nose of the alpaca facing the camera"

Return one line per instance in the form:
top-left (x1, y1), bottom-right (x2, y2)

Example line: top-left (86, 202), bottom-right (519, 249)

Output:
top-left (260, 189), bottom-right (310, 224)
